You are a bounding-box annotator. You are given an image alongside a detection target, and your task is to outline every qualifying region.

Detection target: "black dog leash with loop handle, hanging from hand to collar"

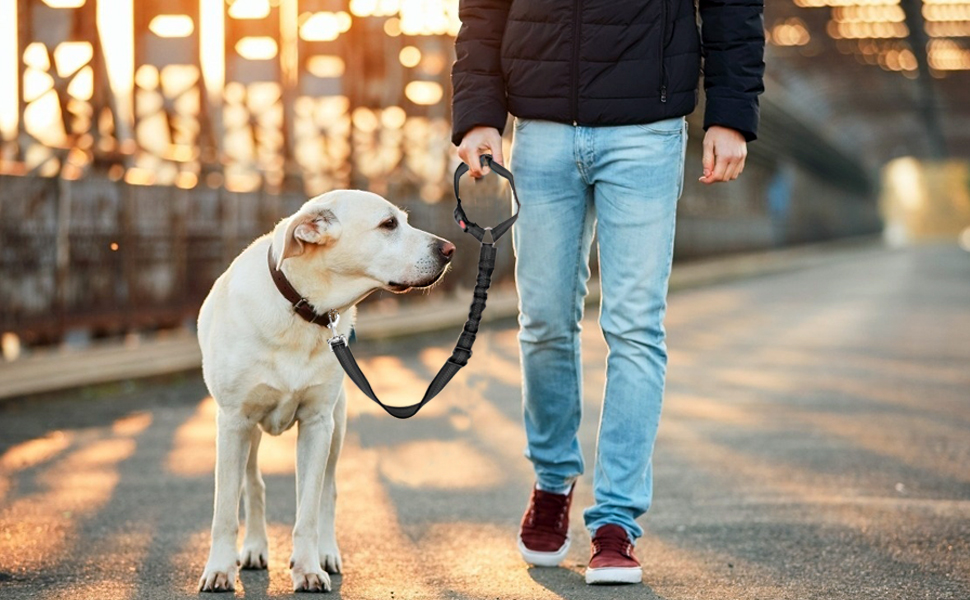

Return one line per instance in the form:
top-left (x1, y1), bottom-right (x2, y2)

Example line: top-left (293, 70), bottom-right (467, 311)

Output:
top-left (328, 154), bottom-right (520, 419)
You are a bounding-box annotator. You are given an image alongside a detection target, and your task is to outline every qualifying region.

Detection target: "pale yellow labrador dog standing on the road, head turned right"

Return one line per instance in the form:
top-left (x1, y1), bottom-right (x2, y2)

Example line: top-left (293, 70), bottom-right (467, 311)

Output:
top-left (199, 190), bottom-right (455, 592)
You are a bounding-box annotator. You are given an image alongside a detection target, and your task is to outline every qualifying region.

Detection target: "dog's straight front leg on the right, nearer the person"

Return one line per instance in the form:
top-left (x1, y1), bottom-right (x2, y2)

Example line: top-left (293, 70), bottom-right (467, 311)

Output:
top-left (290, 414), bottom-right (334, 592)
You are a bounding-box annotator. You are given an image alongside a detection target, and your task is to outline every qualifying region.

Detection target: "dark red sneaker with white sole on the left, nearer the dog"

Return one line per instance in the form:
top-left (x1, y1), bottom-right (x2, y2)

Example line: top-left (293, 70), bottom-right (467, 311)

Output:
top-left (519, 483), bottom-right (576, 567)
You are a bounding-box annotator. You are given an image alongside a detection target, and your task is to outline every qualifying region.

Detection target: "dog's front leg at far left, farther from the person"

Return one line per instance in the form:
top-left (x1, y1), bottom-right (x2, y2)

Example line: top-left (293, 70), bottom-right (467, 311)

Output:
top-left (199, 407), bottom-right (252, 592)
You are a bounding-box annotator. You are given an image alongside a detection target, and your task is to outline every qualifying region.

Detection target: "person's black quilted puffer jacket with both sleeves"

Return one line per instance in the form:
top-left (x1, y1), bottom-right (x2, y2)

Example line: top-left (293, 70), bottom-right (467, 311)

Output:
top-left (452, 0), bottom-right (765, 145)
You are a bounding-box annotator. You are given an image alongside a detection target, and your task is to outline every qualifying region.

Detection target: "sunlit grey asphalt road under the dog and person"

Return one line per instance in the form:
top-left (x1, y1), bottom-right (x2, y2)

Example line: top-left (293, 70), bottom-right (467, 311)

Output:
top-left (0, 247), bottom-right (970, 600)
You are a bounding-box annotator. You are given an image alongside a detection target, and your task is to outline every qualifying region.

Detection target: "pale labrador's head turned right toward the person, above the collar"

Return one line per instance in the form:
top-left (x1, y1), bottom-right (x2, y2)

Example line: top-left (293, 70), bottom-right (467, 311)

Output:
top-left (273, 190), bottom-right (455, 294)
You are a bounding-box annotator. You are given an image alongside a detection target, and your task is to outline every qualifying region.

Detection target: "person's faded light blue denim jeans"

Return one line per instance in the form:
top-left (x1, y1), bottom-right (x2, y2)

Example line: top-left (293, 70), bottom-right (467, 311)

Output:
top-left (510, 117), bottom-right (687, 540)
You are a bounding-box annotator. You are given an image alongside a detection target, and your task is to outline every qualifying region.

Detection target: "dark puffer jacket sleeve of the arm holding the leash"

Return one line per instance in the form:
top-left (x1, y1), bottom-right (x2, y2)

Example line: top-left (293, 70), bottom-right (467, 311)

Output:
top-left (451, 0), bottom-right (511, 146)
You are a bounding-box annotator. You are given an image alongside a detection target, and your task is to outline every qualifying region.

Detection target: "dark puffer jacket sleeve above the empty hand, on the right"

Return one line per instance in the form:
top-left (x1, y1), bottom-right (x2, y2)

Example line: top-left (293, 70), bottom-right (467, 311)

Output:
top-left (699, 0), bottom-right (765, 142)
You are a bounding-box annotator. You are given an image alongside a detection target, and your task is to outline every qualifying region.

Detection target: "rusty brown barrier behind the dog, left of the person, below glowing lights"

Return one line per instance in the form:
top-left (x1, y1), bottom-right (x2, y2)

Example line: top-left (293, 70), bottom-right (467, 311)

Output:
top-left (0, 176), bottom-right (513, 345)
